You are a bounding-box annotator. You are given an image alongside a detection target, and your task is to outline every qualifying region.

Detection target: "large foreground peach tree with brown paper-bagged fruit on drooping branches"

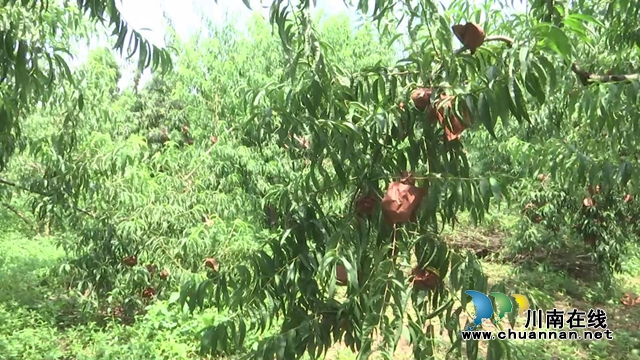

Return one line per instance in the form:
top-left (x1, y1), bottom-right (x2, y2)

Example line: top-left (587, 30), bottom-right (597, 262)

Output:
top-left (176, 1), bottom-right (637, 359)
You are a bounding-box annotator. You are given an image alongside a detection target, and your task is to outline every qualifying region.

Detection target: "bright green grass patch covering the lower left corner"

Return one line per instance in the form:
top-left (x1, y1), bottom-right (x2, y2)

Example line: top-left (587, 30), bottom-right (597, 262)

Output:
top-left (0, 233), bottom-right (204, 360)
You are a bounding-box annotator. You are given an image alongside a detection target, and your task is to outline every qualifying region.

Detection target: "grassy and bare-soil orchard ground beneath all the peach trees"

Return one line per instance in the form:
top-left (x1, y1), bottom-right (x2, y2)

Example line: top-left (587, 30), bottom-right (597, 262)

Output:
top-left (0, 213), bottom-right (640, 360)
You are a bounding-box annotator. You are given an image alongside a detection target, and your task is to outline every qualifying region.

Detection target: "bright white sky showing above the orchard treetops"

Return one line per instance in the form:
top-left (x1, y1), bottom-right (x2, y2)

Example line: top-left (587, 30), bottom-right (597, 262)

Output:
top-left (85, 0), bottom-right (525, 88)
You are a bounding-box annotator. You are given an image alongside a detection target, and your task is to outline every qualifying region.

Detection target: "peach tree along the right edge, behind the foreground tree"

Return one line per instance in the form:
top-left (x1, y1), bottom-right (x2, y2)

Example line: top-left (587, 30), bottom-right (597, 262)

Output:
top-left (460, 2), bottom-right (638, 285)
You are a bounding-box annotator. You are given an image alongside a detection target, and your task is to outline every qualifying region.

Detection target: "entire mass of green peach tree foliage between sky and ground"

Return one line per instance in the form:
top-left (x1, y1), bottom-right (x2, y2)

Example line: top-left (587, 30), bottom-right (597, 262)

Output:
top-left (0, 1), bottom-right (640, 359)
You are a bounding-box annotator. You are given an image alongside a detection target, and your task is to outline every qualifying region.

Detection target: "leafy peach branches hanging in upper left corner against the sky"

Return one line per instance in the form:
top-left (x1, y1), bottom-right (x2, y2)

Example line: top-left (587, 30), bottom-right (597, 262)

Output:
top-left (0, 0), bottom-right (170, 170)
